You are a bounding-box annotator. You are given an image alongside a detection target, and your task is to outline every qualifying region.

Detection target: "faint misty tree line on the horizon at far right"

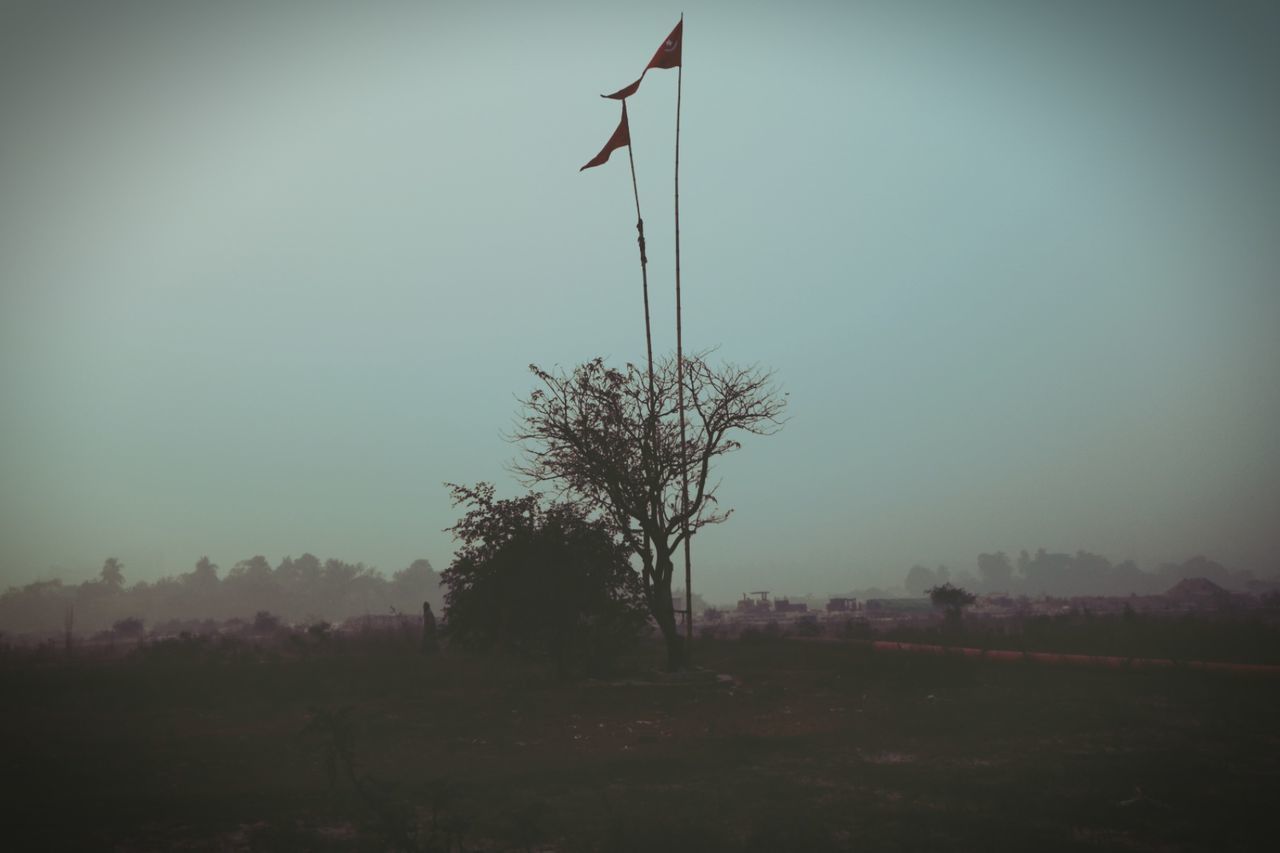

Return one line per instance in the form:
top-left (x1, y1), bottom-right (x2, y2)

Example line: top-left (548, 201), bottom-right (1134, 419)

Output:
top-left (904, 548), bottom-right (1276, 597)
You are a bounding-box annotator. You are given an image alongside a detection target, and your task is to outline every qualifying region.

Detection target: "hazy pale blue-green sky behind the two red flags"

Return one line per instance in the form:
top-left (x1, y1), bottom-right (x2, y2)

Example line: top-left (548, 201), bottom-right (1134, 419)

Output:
top-left (0, 0), bottom-right (1280, 599)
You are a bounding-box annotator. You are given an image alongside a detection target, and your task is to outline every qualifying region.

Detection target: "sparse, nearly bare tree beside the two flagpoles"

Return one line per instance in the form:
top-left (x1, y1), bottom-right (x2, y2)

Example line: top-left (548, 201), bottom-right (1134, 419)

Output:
top-left (509, 353), bottom-right (786, 669)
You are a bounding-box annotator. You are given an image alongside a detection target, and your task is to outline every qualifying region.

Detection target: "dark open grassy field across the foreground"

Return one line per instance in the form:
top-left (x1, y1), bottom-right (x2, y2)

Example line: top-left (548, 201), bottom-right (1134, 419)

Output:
top-left (0, 627), bottom-right (1280, 852)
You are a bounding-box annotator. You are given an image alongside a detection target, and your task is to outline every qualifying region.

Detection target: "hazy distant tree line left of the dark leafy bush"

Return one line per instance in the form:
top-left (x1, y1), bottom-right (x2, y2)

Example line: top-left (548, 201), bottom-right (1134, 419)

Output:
top-left (0, 553), bottom-right (443, 634)
